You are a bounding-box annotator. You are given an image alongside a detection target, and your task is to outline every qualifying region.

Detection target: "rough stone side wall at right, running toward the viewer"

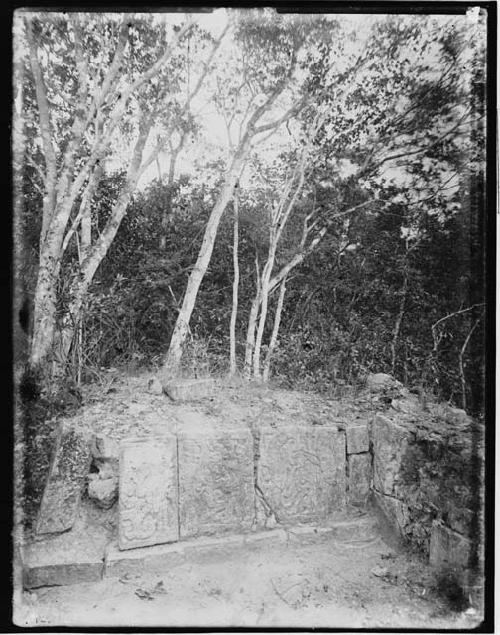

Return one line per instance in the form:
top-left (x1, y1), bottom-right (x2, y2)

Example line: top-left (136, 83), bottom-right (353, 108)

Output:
top-left (370, 404), bottom-right (484, 596)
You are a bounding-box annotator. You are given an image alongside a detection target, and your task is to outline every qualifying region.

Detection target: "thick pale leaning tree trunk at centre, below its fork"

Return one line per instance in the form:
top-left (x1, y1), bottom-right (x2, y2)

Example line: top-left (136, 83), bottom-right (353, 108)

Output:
top-left (161, 136), bottom-right (250, 385)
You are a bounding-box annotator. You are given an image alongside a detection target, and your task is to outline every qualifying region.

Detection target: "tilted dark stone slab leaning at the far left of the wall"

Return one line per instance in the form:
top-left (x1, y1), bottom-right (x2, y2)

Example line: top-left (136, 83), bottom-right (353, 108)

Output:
top-left (36, 425), bottom-right (91, 534)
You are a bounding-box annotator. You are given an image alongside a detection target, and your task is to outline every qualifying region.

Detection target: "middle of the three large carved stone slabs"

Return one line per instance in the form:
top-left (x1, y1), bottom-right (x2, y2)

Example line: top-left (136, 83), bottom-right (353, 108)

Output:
top-left (178, 427), bottom-right (255, 538)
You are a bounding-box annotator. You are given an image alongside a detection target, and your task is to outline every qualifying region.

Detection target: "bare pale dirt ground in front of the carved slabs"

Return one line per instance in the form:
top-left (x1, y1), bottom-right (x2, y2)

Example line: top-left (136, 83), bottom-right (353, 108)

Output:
top-left (15, 520), bottom-right (479, 630)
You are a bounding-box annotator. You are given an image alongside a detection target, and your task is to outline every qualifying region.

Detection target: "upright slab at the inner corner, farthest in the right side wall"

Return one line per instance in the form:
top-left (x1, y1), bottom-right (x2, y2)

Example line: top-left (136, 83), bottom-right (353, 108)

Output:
top-left (371, 415), bottom-right (410, 495)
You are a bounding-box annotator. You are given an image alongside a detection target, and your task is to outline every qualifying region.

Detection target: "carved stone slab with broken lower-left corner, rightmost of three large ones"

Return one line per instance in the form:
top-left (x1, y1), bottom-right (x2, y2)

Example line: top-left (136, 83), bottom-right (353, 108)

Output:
top-left (257, 426), bottom-right (346, 522)
